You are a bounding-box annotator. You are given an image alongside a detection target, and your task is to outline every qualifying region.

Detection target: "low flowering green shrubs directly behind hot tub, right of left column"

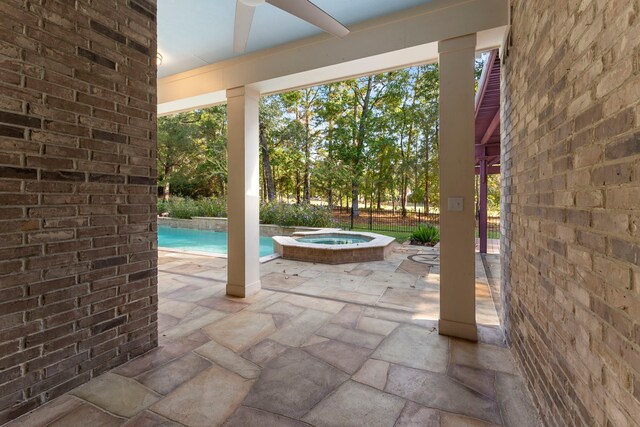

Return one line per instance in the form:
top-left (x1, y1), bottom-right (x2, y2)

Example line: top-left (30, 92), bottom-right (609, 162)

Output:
top-left (260, 202), bottom-right (333, 227)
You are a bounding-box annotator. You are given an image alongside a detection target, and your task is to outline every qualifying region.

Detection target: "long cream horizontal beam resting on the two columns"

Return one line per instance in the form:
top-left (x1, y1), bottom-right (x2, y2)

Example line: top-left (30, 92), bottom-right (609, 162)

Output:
top-left (158, 0), bottom-right (508, 115)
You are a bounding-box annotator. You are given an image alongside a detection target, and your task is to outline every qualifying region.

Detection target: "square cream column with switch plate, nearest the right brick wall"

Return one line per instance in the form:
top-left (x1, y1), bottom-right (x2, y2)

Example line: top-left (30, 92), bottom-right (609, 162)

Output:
top-left (438, 34), bottom-right (477, 341)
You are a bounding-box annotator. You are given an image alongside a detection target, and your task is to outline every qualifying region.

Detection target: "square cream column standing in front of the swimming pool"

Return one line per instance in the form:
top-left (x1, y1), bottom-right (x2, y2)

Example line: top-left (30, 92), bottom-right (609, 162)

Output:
top-left (227, 87), bottom-right (260, 298)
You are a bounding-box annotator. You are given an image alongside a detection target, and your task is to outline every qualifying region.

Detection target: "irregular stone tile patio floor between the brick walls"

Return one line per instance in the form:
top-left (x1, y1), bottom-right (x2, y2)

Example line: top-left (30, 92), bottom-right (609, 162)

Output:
top-left (10, 246), bottom-right (539, 427)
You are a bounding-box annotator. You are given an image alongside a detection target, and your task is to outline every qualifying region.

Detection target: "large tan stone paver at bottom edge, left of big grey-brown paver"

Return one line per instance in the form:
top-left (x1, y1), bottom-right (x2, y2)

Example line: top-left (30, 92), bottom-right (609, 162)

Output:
top-left (150, 366), bottom-right (253, 427)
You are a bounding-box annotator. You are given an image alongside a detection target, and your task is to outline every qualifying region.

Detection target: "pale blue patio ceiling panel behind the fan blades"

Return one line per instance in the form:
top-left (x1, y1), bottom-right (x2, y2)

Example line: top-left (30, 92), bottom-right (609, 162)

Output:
top-left (158, 0), bottom-right (432, 78)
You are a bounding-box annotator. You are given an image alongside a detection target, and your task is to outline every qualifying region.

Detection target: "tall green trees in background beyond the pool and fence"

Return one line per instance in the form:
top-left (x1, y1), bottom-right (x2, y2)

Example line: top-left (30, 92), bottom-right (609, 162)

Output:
top-left (158, 57), bottom-right (500, 214)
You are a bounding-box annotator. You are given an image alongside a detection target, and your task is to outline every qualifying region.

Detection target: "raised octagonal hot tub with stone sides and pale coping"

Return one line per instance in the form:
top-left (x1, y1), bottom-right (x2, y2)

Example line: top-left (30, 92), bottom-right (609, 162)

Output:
top-left (273, 229), bottom-right (395, 264)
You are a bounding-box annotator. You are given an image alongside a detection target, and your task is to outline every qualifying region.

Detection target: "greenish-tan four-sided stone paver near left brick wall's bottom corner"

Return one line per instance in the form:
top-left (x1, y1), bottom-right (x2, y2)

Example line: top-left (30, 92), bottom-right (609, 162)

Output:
top-left (73, 373), bottom-right (161, 417)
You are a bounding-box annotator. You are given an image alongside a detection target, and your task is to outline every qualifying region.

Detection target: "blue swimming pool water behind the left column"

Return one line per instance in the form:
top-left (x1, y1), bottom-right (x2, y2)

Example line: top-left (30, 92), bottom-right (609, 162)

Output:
top-left (158, 225), bottom-right (274, 257)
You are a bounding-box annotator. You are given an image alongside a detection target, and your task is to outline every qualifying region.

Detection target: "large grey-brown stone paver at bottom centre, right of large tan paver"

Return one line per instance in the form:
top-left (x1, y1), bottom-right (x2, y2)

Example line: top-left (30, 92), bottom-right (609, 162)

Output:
top-left (244, 348), bottom-right (349, 419)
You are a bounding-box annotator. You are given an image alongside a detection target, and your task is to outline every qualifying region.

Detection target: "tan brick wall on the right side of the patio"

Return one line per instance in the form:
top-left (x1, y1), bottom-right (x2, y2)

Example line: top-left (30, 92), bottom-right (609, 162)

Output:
top-left (502, 0), bottom-right (640, 426)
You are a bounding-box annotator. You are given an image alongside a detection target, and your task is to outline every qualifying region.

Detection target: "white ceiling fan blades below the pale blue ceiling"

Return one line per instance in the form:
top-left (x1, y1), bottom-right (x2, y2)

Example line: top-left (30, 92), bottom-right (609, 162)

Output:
top-left (233, 0), bottom-right (349, 52)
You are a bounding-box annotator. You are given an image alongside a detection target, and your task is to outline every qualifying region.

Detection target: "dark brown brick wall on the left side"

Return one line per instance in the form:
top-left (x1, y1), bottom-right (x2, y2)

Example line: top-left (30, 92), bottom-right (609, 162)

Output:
top-left (0, 0), bottom-right (157, 424)
